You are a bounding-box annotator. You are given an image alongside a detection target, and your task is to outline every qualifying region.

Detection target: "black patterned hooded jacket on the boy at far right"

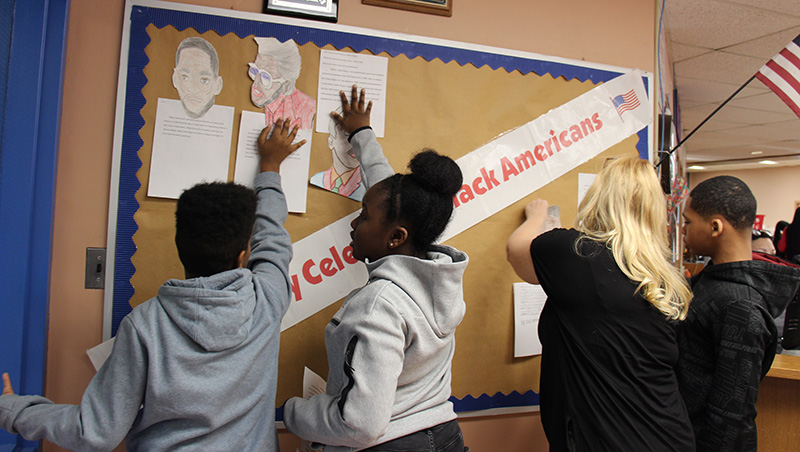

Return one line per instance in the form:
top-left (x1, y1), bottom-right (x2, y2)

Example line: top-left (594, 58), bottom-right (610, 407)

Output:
top-left (676, 260), bottom-right (800, 452)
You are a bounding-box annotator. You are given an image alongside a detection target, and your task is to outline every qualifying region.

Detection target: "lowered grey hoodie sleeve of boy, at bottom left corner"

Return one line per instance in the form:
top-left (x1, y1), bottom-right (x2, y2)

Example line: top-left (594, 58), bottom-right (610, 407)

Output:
top-left (0, 317), bottom-right (147, 451)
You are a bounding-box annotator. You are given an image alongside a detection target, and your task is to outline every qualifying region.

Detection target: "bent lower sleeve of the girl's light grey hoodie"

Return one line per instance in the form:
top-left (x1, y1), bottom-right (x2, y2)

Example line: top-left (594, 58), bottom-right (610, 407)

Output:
top-left (284, 282), bottom-right (405, 449)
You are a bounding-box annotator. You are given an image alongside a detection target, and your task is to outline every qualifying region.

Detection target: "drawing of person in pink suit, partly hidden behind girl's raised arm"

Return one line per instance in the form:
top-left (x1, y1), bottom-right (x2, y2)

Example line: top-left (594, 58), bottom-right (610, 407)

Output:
top-left (311, 108), bottom-right (365, 201)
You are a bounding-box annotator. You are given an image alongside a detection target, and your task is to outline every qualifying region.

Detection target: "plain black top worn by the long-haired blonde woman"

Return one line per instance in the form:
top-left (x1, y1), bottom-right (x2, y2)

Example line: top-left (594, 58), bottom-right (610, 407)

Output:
top-left (531, 229), bottom-right (694, 452)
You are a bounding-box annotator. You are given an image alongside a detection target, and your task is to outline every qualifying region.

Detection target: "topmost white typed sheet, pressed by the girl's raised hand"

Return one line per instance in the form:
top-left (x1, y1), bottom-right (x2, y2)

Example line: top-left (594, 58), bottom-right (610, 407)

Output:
top-left (316, 50), bottom-right (389, 137)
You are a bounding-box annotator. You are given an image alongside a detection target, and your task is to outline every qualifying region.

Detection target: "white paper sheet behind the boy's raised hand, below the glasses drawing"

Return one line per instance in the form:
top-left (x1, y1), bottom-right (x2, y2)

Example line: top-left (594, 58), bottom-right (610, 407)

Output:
top-left (233, 110), bottom-right (313, 213)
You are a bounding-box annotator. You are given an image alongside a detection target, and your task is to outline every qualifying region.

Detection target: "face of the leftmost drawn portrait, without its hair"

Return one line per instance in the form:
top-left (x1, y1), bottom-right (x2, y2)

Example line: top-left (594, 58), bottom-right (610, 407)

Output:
top-left (172, 48), bottom-right (222, 118)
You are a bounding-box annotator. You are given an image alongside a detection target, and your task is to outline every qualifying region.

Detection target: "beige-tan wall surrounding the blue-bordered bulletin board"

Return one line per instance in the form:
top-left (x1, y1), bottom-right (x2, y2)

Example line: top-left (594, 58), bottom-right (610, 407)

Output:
top-left (46, 0), bottom-right (655, 452)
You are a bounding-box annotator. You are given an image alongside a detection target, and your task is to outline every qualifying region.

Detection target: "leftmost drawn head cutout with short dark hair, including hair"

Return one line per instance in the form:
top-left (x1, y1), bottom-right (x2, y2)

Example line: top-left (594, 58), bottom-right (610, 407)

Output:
top-left (172, 37), bottom-right (222, 118)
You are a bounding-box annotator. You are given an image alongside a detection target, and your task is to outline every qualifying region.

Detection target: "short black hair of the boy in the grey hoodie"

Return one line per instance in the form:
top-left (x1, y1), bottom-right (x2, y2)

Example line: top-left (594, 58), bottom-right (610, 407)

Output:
top-left (175, 182), bottom-right (256, 277)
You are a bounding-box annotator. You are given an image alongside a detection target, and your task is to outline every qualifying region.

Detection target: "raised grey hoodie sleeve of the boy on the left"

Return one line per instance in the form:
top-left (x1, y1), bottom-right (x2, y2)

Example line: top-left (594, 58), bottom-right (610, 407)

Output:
top-left (248, 171), bottom-right (292, 318)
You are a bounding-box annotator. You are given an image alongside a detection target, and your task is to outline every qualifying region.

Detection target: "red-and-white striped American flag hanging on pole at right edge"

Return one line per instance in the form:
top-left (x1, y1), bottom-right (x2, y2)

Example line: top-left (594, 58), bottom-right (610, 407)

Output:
top-left (756, 36), bottom-right (800, 116)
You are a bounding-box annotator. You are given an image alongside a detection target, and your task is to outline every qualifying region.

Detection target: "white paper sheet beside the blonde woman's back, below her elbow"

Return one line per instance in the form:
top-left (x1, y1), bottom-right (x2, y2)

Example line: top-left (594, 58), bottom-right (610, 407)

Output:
top-left (514, 283), bottom-right (547, 358)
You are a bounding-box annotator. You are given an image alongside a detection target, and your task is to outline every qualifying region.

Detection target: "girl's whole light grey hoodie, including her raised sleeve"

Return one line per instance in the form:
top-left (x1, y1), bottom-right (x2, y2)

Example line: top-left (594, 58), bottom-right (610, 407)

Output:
top-left (284, 129), bottom-right (468, 452)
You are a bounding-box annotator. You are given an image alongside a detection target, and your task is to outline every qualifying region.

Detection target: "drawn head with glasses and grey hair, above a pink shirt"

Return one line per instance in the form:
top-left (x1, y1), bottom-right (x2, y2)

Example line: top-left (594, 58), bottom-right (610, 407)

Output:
top-left (247, 38), bottom-right (302, 107)
